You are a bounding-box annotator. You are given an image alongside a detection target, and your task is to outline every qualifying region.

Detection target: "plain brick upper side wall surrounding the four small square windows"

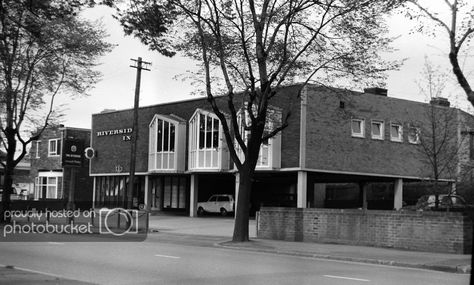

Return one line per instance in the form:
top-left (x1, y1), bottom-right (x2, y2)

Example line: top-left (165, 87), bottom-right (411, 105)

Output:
top-left (306, 86), bottom-right (456, 178)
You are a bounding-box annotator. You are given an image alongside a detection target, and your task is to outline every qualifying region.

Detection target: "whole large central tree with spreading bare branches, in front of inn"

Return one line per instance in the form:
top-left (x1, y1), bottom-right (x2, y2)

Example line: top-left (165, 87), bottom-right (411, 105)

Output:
top-left (117, 0), bottom-right (399, 241)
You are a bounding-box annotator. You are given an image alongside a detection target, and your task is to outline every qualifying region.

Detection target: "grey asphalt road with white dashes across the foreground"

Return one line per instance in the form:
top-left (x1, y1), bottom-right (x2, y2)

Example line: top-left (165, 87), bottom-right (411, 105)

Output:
top-left (0, 233), bottom-right (469, 285)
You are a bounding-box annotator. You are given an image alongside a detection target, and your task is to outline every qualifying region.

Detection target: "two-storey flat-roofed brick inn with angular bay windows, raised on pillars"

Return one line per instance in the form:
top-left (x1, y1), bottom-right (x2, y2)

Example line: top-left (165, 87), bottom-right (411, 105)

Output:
top-left (90, 85), bottom-right (474, 216)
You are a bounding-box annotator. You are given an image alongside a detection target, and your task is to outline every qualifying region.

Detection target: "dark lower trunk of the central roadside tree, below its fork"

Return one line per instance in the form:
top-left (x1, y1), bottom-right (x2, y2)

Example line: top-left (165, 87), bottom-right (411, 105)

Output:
top-left (232, 165), bottom-right (254, 242)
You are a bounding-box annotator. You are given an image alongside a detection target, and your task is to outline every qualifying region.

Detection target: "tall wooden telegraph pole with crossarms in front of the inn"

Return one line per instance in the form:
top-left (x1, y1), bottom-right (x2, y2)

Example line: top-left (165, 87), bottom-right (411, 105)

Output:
top-left (125, 57), bottom-right (151, 209)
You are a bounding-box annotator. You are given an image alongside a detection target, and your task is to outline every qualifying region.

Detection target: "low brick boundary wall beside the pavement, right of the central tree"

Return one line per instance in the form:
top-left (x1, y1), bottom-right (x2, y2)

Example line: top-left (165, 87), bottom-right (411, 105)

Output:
top-left (257, 207), bottom-right (472, 254)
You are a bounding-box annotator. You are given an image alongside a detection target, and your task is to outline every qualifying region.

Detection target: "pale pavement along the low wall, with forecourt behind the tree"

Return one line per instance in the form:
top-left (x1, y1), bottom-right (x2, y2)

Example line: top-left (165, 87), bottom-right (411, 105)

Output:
top-left (149, 216), bottom-right (471, 273)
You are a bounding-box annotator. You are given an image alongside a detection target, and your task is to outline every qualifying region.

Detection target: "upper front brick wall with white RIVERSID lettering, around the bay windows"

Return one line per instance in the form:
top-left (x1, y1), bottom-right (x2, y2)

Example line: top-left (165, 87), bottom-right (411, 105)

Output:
top-left (91, 86), bottom-right (300, 174)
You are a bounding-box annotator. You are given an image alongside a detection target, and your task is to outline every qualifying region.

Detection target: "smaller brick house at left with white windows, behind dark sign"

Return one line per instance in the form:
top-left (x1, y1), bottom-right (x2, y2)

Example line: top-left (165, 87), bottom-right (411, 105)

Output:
top-left (30, 125), bottom-right (92, 209)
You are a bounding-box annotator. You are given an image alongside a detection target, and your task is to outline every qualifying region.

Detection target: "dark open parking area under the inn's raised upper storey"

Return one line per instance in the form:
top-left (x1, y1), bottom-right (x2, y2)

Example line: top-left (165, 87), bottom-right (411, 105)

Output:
top-left (190, 170), bottom-right (450, 216)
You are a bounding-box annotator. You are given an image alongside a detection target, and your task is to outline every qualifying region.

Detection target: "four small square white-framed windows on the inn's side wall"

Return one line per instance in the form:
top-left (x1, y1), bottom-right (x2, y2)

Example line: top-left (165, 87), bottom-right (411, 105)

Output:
top-left (351, 119), bottom-right (420, 144)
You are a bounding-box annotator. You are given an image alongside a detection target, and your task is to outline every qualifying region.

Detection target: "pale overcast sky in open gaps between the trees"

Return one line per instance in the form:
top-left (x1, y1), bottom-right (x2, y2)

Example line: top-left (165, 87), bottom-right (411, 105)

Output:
top-left (57, 1), bottom-right (474, 128)
